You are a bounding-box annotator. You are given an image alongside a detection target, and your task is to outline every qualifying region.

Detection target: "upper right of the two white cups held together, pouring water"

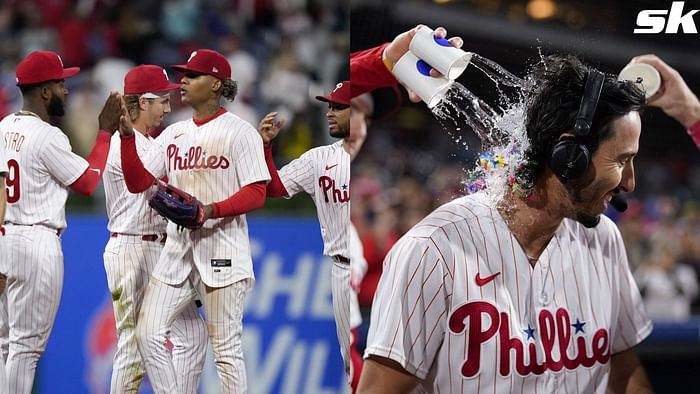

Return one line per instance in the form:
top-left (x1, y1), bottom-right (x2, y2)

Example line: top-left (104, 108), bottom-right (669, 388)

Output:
top-left (409, 26), bottom-right (472, 81)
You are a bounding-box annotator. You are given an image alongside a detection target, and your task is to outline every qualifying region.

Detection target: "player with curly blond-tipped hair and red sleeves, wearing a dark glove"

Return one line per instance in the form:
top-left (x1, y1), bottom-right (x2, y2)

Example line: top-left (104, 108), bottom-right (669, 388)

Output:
top-left (115, 49), bottom-right (270, 393)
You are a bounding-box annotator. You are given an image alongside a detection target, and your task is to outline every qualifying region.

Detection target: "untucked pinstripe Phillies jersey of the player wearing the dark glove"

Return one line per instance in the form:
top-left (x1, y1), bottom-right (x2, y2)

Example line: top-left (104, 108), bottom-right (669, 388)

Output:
top-left (143, 112), bottom-right (270, 287)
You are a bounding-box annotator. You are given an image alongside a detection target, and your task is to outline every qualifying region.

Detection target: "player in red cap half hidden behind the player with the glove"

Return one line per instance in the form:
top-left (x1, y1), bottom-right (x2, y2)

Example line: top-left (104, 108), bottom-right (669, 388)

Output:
top-left (104, 65), bottom-right (208, 393)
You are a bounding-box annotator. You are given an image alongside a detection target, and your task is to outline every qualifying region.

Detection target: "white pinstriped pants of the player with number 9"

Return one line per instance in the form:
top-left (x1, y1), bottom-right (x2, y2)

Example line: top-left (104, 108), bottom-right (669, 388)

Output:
top-left (0, 225), bottom-right (63, 394)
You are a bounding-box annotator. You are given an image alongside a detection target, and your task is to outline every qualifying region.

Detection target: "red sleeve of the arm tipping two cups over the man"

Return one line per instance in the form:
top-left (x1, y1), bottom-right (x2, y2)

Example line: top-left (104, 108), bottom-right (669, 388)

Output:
top-left (350, 43), bottom-right (398, 97)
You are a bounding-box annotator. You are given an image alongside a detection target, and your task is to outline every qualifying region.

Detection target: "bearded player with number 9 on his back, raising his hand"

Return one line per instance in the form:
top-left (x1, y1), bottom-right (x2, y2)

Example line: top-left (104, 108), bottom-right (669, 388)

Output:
top-left (0, 51), bottom-right (121, 393)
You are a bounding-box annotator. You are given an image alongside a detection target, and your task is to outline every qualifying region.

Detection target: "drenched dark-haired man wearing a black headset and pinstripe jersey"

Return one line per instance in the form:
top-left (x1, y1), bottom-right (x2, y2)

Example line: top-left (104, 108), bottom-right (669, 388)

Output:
top-left (359, 57), bottom-right (652, 393)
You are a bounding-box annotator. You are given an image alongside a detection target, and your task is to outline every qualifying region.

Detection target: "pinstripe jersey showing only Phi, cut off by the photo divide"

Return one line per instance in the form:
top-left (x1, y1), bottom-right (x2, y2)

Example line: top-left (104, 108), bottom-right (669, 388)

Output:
top-left (279, 140), bottom-right (350, 258)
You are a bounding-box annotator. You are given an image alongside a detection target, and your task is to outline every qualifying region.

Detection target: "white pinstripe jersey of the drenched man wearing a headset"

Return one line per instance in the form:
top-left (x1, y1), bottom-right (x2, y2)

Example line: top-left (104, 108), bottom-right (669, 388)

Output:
top-left (365, 194), bottom-right (652, 393)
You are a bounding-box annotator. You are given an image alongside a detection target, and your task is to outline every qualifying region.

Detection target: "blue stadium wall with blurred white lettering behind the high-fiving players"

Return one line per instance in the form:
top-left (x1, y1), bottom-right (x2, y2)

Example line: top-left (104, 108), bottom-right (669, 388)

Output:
top-left (34, 216), bottom-right (345, 394)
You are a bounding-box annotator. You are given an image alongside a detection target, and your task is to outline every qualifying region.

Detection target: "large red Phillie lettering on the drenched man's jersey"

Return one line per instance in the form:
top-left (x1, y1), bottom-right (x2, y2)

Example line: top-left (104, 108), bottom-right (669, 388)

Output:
top-left (448, 301), bottom-right (610, 378)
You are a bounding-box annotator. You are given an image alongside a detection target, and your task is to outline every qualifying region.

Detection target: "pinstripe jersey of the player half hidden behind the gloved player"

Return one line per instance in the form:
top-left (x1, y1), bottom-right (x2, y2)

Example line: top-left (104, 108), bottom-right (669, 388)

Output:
top-left (103, 132), bottom-right (168, 235)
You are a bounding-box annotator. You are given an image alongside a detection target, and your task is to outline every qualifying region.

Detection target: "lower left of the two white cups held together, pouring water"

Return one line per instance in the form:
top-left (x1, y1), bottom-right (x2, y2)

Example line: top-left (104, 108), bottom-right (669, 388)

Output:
top-left (392, 51), bottom-right (454, 108)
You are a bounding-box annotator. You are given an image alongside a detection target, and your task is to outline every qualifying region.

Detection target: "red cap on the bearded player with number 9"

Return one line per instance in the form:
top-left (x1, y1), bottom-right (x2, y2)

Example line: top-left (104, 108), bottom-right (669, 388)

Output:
top-left (16, 51), bottom-right (80, 86)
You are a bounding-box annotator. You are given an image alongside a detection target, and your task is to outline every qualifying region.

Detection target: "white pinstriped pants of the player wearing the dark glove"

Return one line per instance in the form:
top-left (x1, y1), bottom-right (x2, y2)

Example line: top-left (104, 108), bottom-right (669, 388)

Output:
top-left (136, 269), bottom-right (253, 394)
